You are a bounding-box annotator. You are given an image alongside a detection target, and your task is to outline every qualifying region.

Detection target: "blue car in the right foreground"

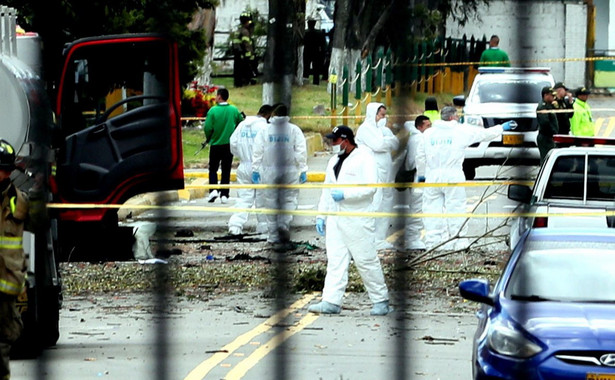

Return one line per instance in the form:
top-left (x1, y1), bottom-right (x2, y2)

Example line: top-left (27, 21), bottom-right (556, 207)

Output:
top-left (459, 228), bottom-right (615, 380)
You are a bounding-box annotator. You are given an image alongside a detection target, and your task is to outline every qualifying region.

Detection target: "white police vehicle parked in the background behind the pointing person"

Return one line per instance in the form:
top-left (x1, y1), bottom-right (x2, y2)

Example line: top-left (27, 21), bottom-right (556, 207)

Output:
top-left (454, 67), bottom-right (554, 179)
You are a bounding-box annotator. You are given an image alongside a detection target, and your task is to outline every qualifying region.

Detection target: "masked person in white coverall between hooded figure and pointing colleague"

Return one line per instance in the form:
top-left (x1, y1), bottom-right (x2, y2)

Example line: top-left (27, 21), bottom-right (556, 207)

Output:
top-left (404, 115), bottom-right (431, 250)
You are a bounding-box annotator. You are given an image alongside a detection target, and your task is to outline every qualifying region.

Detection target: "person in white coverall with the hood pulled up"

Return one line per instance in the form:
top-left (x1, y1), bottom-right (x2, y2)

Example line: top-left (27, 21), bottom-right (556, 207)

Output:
top-left (356, 103), bottom-right (399, 249)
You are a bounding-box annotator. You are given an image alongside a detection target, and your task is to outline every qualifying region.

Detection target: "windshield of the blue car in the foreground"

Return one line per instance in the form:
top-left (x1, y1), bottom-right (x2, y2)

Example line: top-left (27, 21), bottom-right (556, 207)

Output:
top-left (506, 249), bottom-right (615, 302)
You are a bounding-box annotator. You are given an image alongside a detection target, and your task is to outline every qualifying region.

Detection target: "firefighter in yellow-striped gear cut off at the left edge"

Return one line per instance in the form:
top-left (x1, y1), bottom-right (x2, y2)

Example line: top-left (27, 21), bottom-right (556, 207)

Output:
top-left (0, 140), bottom-right (43, 379)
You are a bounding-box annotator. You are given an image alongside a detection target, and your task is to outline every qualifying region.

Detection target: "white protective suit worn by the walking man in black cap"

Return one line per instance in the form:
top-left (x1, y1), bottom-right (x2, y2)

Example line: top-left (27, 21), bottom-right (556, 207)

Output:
top-left (318, 147), bottom-right (389, 306)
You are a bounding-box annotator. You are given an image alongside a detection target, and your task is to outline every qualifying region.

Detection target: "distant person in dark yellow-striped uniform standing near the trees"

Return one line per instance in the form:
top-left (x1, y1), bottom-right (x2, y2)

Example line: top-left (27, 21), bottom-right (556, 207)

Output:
top-left (233, 12), bottom-right (256, 87)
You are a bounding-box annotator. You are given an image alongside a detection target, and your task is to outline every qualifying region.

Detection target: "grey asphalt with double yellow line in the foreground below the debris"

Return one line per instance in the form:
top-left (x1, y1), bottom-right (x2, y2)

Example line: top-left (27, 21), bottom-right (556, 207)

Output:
top-left (11, 293), bottom-right (475, 380)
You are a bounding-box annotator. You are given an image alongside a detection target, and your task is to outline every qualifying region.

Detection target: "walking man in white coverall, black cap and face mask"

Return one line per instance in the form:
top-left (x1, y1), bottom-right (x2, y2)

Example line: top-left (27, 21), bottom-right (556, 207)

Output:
top-left (308, 125), bottom-right (391, 315)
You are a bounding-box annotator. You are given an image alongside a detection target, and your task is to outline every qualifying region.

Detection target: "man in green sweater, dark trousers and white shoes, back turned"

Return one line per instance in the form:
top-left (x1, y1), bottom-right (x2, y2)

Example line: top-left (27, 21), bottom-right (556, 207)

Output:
top-left (203, 88), bottom-right (243, 203)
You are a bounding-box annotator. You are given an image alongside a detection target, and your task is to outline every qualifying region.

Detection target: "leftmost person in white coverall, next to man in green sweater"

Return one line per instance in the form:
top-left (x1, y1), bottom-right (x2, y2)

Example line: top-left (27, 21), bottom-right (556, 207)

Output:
top-left (228, 104), bottom-right (273, 235)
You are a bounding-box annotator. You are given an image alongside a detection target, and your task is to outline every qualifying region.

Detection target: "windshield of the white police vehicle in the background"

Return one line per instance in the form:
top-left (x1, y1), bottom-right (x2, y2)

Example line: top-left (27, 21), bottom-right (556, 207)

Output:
top-left (471, 79), bottom-right (551, 103)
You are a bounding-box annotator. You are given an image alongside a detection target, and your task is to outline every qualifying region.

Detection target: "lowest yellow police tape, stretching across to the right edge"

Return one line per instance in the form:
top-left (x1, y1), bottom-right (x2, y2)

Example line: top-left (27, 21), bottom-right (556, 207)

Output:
top-left (47, 203), bottom-right (615, 219)
